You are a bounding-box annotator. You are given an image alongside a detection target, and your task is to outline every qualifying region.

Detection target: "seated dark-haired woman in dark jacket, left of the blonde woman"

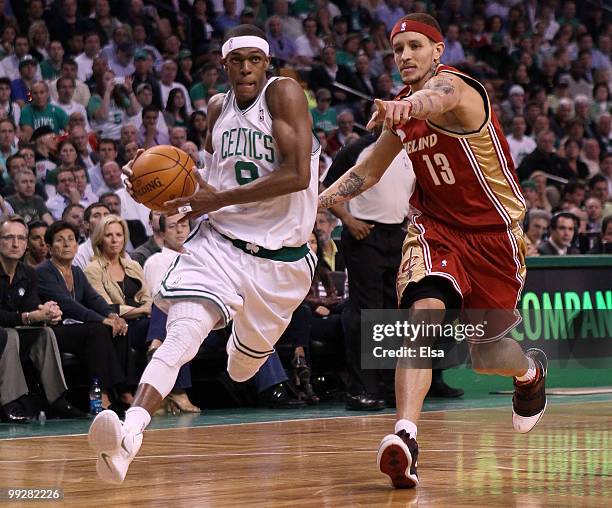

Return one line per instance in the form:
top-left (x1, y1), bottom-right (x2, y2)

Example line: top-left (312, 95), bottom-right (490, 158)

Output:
top-left (36, 221), bottom-right (131, 408)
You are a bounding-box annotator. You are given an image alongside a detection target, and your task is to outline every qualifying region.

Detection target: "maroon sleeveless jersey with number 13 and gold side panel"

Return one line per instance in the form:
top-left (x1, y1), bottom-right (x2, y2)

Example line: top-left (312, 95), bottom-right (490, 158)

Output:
top-left (397, 65), bottom-right (525, 230)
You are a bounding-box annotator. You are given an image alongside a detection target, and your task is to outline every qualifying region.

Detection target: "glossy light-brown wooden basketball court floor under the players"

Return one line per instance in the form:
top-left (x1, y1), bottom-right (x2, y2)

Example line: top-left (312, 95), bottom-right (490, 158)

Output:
top-left (0, 399), bottom-right (612, 508)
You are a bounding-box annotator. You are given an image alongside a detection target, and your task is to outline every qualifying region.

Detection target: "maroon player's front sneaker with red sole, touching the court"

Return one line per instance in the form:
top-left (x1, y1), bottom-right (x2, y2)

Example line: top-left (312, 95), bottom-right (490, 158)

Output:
top-left (376, 430), bottom-right (419, 489)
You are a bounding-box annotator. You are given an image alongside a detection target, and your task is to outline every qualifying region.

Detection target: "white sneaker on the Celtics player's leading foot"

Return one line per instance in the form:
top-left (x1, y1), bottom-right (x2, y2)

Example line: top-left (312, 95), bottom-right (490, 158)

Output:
top-left (88, 409), bottom-right (142, 484)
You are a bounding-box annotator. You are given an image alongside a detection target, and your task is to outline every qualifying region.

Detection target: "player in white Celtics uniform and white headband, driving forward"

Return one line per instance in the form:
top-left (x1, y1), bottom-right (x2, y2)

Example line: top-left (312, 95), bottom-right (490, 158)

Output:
top-left (89, 25), bottom-right (320, 483)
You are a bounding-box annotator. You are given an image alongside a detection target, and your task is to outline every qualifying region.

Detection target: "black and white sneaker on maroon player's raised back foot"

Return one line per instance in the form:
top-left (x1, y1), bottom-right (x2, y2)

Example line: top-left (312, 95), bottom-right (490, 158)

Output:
top-left (512, 348), bottom-right (548, 434)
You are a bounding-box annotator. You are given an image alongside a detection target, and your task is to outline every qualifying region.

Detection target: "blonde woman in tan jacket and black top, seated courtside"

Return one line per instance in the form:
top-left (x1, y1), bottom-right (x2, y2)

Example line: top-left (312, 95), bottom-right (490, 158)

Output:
top-left (85, 215), bottom-right (153, 392)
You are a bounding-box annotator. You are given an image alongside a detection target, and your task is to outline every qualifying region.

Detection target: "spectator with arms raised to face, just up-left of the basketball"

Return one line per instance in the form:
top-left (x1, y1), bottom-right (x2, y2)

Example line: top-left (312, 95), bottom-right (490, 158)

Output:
top-left (87, 70), bottom-right (140, 140)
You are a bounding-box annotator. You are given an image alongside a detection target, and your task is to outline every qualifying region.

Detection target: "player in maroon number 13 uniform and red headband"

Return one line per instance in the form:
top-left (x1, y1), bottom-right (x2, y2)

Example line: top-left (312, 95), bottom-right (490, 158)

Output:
top-left (319, 14), bottom-right (547, 488)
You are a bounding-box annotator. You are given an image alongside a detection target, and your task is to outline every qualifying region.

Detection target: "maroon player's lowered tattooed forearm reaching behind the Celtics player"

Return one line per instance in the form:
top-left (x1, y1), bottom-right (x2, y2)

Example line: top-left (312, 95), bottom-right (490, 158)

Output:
top-left (319, 130), bottom-right (402, 208)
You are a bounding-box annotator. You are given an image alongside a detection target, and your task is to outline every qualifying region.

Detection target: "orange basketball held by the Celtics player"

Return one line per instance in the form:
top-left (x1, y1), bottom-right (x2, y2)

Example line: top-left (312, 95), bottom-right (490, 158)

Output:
top-left (130, 145), bottom-right (197, 212)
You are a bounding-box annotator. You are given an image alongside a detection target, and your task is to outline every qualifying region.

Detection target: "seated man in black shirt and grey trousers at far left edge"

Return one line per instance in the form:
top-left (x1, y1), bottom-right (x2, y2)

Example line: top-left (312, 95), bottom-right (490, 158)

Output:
top-left (0, 215), bottom-right (85, 422)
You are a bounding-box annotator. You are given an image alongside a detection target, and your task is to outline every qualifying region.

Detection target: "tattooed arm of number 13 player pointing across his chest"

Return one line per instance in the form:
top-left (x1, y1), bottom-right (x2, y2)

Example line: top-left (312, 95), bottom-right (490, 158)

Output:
top-left (367, 72), bottom-right (464, 129)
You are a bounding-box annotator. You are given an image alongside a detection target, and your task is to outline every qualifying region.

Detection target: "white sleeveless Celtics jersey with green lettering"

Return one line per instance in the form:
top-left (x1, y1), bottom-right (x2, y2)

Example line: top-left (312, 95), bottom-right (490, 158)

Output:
top-left (208, 78), bottom-right (321, 250)
